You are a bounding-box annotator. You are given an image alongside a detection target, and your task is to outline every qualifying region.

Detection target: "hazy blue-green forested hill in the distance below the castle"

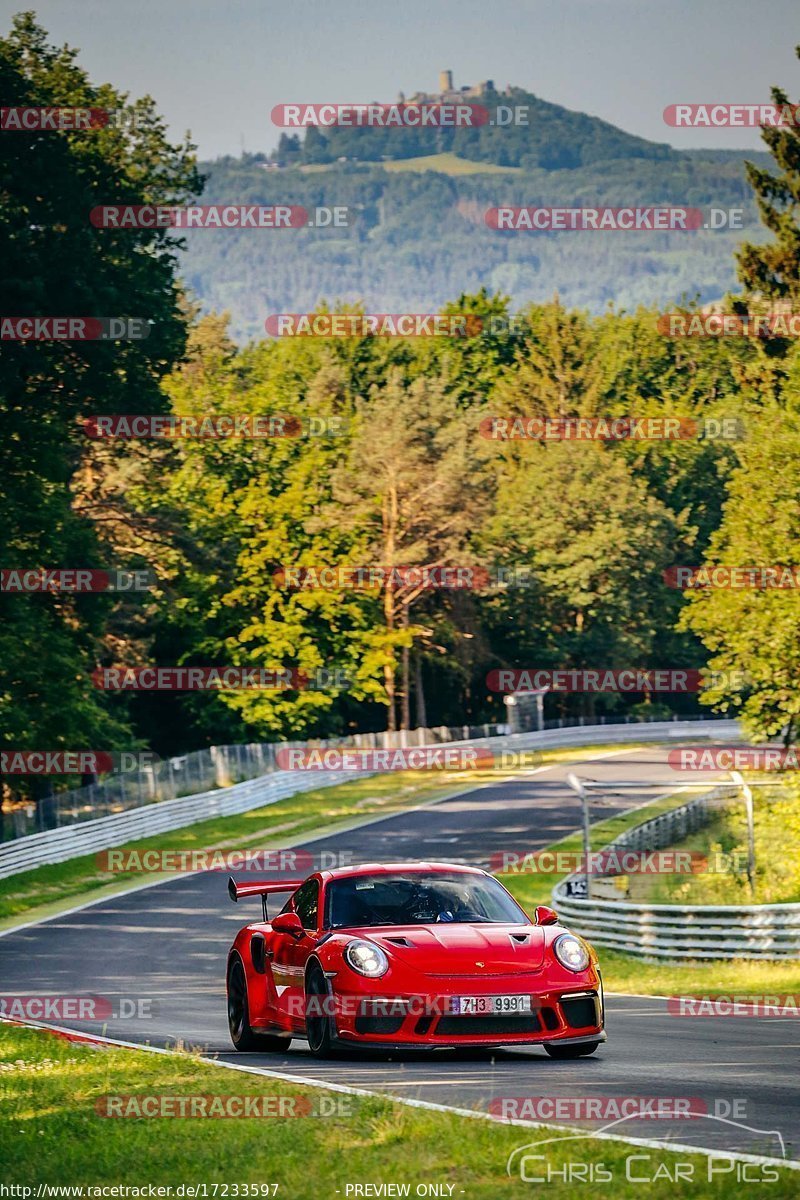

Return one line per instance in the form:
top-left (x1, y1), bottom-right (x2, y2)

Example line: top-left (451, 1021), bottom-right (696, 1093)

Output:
top-left (182, 82), bottom-right (766, 338)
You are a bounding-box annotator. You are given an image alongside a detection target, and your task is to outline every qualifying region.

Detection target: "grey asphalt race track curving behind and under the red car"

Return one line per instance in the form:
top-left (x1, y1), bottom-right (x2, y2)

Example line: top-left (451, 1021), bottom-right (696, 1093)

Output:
top-left (0, 746), bottom-right (800, 1159)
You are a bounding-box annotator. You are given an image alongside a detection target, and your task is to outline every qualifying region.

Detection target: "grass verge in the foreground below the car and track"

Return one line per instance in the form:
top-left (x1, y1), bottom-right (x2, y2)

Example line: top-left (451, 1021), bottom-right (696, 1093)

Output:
top-left (0, 1026), bottom-right (800, 1200)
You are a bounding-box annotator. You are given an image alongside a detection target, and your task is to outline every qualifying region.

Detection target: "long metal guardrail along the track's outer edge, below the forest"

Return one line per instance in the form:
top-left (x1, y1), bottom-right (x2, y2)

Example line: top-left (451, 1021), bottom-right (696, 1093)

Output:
top-left (0, 720), bottom-right (739, 878)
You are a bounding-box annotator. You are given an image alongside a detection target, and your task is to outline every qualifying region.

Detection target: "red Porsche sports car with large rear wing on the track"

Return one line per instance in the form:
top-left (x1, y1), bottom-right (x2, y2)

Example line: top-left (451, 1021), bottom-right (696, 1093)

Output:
top-left (221, 863), bottom-right (606, 1058)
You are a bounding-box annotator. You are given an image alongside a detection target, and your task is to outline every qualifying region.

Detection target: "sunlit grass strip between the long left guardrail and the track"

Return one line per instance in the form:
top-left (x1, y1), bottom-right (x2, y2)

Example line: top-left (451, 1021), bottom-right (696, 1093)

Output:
top-left (0, 745), bottom-right (640, 928)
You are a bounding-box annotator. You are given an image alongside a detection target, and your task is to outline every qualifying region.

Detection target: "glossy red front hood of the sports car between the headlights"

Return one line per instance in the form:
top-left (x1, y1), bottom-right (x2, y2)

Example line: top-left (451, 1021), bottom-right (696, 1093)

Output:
top-left (363, 923), bottom-right (545, 977)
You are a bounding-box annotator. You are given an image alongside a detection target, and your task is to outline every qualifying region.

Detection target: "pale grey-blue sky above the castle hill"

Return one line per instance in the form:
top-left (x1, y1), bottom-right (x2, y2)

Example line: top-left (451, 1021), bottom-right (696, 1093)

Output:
top-left (0, 0), bottom-right (800, 158)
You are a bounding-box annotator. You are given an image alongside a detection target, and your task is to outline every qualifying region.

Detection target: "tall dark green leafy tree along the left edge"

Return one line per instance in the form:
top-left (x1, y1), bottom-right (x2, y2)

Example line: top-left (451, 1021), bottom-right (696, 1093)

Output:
top-left (0, 13), bottom-right (199, 792)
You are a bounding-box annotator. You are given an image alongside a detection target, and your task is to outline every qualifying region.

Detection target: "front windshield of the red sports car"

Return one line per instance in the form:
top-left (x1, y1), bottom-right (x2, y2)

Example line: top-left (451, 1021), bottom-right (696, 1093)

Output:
top-left (325, 871), bottom-right (530, 929)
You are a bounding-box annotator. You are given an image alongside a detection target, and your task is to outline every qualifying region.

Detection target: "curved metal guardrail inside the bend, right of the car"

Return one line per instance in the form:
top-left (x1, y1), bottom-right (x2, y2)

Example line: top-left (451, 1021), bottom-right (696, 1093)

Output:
top-left (553, 772), bottom-right (800, 960)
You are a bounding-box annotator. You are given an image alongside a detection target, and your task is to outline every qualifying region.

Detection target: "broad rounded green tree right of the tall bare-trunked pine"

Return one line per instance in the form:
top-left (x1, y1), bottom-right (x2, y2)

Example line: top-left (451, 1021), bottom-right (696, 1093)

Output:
top-left (488, 443), bottom-right (676, 713)
